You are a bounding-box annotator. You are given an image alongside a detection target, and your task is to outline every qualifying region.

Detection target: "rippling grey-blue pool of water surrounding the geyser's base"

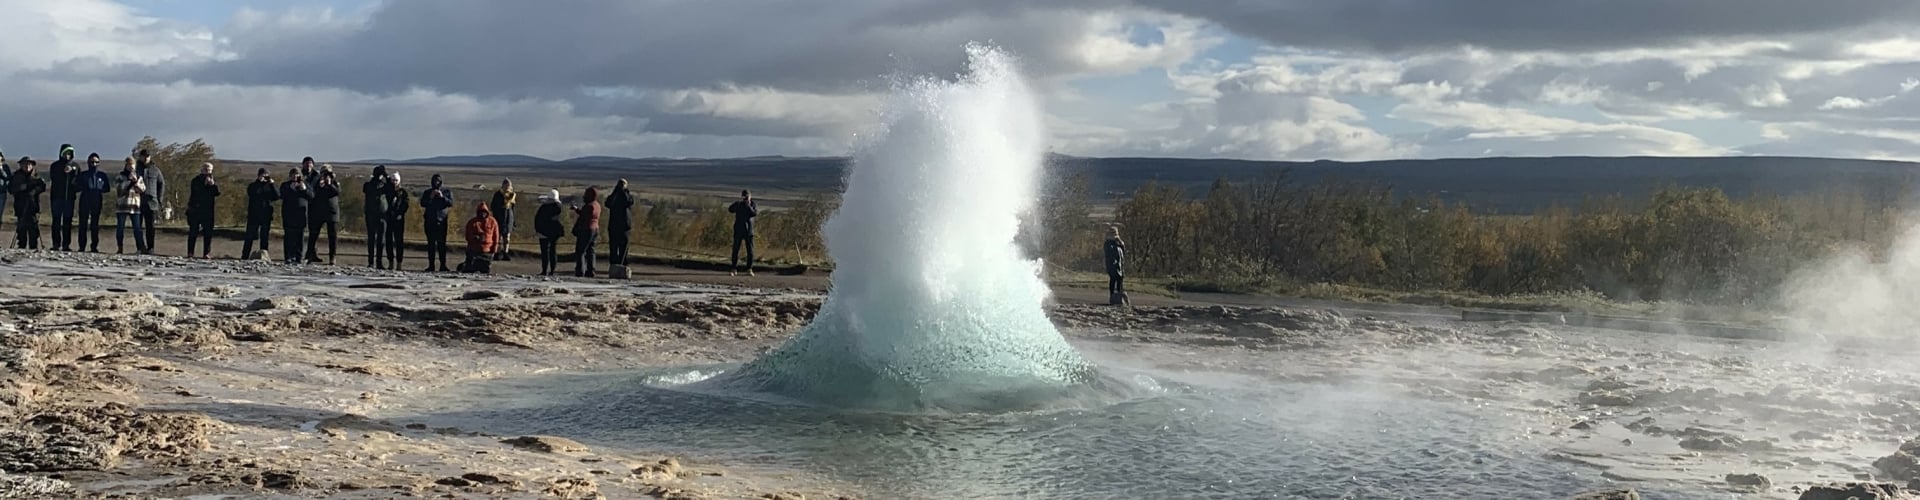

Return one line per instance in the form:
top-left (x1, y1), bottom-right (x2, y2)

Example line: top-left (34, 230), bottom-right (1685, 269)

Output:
top-left (389, 361), bottom-right (1697, 498)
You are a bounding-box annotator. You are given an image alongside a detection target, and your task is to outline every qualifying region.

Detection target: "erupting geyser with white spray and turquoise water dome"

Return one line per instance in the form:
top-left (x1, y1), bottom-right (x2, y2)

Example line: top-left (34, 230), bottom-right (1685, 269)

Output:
top-left (708, 46), bottom-right (1098, 412)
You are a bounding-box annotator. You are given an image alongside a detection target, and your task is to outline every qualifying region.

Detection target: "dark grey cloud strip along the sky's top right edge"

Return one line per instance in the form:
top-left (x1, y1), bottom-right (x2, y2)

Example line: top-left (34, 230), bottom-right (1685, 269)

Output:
top-left (1133, 0), bottom-right (1920, 52)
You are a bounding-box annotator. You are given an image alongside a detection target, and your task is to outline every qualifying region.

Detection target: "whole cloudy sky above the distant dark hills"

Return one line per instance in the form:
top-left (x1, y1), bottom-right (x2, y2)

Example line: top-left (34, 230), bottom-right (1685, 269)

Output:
top-left (0, 0), bottom-right (1920, 162)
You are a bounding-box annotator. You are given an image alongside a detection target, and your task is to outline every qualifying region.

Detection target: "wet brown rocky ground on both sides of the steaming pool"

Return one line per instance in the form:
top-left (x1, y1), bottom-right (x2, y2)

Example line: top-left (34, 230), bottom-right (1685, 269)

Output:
top-left (0, 252), bottom-right (1920, 498)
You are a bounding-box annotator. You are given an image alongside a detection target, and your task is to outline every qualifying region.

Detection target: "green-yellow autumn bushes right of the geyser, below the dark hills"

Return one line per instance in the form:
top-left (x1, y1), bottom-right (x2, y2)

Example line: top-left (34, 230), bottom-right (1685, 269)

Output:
top-left (1116, 177), bottom-right (1899, 306)
